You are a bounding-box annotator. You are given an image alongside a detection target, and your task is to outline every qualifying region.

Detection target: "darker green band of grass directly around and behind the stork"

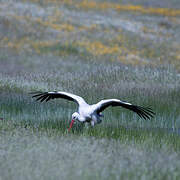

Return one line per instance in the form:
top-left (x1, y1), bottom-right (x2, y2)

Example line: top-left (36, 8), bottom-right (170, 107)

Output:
top-left (1, 89), bottom-right (180, 151)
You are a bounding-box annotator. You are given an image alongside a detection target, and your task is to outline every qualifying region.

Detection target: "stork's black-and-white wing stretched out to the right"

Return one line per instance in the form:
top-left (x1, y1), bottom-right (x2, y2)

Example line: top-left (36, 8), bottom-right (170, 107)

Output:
top-left (96, 99), bottom-right (155, 119)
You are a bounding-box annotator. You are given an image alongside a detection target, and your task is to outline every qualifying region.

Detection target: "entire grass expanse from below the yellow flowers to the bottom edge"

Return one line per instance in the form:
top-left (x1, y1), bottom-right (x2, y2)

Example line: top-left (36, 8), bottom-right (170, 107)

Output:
top-left (0, 56), bottom-right (180, 179)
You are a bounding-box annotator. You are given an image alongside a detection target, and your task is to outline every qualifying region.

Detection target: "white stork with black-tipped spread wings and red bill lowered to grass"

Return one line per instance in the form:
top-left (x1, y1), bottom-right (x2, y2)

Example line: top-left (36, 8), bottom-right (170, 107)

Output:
top-left (31, 91), bottom-right (155, 130)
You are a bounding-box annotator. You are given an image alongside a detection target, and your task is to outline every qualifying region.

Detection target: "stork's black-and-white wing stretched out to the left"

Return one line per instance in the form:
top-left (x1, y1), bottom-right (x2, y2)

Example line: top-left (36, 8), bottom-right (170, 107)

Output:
top-left (31, 91), bottom-right (86, 105)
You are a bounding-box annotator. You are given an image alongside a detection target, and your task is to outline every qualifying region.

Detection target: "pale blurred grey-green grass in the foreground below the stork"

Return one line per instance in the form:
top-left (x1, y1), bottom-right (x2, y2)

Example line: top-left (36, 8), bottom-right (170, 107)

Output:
top-left (0, 127), bottom-right (180, 179)
